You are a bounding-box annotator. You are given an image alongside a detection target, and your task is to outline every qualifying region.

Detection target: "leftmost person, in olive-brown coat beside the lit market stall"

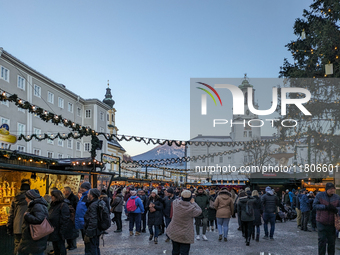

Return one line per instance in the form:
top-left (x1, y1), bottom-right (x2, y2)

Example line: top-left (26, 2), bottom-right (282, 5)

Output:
top-left (7, 183), bottom-right (30, 253)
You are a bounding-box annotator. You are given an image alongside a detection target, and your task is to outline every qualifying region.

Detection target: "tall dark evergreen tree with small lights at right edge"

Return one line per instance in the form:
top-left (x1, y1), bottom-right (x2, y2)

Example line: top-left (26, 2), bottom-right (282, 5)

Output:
top-left (278, 0), bottom-right (340, 163)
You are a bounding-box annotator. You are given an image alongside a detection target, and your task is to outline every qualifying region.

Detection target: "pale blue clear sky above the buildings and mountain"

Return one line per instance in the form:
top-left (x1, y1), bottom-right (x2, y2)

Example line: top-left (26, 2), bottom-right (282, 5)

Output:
top-left (0, 0), bottom-right (312, 155)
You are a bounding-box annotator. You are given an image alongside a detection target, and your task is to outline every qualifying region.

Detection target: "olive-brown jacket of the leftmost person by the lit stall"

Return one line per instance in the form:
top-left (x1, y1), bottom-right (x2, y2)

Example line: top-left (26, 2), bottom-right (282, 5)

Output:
top-left (7, 191), bottom-right (27, 235)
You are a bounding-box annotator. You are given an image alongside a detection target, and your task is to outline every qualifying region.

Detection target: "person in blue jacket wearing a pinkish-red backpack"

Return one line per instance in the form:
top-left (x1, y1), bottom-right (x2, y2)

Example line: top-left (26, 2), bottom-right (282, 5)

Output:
top-left (125, 190), bottom-right (144, 236)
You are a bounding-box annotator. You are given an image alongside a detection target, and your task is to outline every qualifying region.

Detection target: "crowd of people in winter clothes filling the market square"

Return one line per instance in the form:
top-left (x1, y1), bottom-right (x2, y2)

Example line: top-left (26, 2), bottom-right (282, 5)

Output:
top-left (7, 182), bottom-right (340, 255)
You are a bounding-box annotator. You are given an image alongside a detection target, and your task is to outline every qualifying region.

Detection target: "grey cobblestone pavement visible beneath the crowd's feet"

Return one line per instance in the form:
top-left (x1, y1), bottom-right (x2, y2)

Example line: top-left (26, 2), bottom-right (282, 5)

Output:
top-left (68, 219), bottom-right (340, 255)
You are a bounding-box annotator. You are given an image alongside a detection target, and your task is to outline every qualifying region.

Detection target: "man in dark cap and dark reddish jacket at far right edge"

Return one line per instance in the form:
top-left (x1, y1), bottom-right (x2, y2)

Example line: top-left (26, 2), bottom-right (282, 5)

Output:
top-left (313, 182), bottom-right (340, 254)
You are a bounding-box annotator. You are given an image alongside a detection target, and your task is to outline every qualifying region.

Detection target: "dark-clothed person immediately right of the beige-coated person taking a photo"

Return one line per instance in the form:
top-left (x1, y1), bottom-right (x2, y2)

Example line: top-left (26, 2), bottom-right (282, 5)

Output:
top-left (195, 186), bottom-right (209, 241)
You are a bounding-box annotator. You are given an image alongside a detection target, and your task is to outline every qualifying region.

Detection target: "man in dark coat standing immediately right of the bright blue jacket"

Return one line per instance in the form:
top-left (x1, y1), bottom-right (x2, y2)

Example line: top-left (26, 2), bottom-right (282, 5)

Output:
top-left (84, 189), bottom-right (102, 255)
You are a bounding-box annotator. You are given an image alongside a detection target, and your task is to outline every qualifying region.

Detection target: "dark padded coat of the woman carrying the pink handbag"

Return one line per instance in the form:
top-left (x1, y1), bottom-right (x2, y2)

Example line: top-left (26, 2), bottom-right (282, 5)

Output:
top-left (18, 197), bottom-right (48, 253)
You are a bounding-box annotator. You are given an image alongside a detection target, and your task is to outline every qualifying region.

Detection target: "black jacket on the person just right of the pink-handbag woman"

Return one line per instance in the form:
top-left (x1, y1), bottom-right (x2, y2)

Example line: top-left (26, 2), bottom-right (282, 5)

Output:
top-left (48, 201), bottom-right (70, 242)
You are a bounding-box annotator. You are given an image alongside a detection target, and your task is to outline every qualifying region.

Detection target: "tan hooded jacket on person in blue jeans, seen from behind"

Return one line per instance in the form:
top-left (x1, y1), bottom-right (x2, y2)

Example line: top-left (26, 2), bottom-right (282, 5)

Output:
top-left (214, 190), bottom-right (234, 218)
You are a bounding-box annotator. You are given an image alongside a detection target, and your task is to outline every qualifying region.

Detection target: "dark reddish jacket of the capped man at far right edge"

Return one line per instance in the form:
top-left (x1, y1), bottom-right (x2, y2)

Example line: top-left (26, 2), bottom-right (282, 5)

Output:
top-left (313, 191), bottom-right (340, 226)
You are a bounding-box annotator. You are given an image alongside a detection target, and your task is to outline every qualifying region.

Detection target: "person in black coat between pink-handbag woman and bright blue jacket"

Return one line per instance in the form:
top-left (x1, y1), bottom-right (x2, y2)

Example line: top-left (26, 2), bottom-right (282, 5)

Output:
top-left (48, 190), bottom-right (70, 255)
